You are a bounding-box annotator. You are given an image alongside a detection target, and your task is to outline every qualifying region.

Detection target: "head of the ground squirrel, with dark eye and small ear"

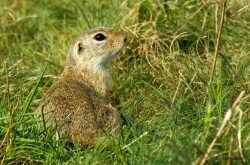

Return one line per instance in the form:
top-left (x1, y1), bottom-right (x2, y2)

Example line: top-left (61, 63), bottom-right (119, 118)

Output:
top-left (66, 27), bottom-right (126, 72)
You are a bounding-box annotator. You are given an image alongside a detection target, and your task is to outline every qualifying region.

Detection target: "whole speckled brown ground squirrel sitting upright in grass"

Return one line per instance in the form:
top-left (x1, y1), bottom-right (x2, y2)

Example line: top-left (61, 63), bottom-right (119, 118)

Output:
top-left (37, 27), bottom-right (126, 146)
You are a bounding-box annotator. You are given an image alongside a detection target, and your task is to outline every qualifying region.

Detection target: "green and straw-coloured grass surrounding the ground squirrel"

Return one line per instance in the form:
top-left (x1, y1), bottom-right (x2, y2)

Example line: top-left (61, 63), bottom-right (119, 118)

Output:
top-left (0, 0), bottom-right (250, 164)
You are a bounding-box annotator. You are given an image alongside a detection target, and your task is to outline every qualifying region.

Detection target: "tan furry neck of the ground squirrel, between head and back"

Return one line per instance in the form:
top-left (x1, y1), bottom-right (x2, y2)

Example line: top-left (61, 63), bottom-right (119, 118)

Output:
top-left (60, 62), bottom-right (112, 97)
